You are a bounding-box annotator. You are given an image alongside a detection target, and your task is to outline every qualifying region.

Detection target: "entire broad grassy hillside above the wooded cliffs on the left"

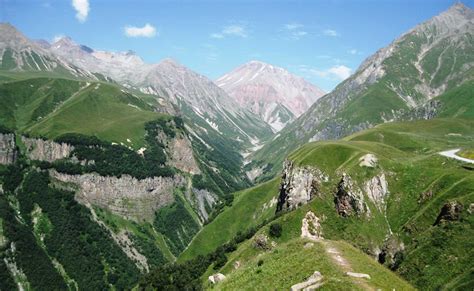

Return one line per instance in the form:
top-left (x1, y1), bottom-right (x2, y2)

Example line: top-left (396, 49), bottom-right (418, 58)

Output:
top-left (0, 78), bottom-right (165, 148)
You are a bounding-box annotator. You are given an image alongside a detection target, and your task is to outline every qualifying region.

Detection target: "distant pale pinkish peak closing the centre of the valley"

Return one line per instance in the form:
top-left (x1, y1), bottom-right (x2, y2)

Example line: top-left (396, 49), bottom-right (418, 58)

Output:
top-left (216, 61), bottom-right (325, 132)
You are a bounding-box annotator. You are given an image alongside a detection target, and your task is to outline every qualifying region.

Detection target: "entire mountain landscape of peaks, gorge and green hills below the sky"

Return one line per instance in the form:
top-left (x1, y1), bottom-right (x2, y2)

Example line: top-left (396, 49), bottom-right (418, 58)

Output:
top-left (0, 3), bottom-right (474, 290)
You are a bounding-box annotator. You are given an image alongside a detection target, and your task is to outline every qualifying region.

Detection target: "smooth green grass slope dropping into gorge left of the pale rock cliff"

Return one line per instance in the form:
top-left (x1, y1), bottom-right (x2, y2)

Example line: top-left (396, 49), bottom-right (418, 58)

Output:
top-left (179, 179), bottom-right (280, 261)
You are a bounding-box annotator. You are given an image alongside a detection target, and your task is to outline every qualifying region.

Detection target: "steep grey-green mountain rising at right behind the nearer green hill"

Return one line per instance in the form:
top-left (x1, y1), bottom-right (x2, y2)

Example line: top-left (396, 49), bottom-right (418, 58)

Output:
top-left (248, 4), bottom-right (474, 181)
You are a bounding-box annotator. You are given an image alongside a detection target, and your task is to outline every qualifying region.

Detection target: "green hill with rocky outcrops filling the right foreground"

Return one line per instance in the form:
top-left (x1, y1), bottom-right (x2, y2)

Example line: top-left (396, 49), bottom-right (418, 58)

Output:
top-left (170, 118), bottom-right (474, 290)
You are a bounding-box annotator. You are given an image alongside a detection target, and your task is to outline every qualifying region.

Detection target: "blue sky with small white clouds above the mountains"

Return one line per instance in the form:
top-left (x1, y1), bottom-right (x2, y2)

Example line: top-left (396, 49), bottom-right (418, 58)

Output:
top-left (0, 0), bottom-right (474, 91)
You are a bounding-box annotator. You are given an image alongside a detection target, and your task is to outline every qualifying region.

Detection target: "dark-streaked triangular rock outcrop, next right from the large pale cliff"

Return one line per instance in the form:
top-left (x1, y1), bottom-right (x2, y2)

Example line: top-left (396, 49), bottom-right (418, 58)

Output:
top-left (334, 173), bottom-right (370, 217)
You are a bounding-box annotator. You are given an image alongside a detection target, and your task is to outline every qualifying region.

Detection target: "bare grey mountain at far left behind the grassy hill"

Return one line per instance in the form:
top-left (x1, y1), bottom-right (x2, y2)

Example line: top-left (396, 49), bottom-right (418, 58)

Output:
top-left (0, 23), bottom-right (99, 80)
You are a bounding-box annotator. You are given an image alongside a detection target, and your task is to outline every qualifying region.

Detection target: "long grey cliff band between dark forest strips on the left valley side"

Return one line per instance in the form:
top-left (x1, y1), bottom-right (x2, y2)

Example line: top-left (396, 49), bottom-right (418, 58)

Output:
top-left (50, 170), bottom-right (186, 221)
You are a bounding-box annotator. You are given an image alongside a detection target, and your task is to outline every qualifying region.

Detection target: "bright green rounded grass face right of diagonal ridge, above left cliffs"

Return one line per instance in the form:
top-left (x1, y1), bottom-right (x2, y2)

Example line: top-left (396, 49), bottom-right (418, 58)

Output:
top-left (25, 83), bottom-right (161, 149)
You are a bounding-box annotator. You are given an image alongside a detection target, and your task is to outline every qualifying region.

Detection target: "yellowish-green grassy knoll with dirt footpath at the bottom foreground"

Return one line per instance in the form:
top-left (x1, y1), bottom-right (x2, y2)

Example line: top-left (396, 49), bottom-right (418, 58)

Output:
top-left (209, 238), bottom-right (414, 290)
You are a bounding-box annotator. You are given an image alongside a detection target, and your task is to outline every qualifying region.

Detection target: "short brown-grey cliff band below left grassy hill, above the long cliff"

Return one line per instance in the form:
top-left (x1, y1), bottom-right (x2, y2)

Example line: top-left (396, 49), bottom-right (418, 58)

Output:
top-left (21, 136), bottom-right (74, 162)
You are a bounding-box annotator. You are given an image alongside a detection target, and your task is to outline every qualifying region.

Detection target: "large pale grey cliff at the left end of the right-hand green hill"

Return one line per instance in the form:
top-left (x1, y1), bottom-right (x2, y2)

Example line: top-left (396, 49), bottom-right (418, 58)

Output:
top-left (277, 160), bottom-right (328, 212)
